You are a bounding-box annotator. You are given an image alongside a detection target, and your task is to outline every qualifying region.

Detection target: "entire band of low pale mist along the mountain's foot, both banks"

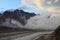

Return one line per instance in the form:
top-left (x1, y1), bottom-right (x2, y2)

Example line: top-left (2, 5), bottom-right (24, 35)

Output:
top-left (0, 12), bottom-right (60, 30)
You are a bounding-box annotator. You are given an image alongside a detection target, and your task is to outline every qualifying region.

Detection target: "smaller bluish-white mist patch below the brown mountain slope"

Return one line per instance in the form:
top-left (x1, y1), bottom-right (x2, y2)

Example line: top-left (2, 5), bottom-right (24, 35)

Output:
top-left (0, 18), bottom-right (23, 28)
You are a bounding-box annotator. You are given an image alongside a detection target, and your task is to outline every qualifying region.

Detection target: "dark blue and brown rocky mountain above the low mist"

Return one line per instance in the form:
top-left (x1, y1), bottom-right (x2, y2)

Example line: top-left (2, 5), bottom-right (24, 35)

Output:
top-left (0, 9), bottom-right (36, 25)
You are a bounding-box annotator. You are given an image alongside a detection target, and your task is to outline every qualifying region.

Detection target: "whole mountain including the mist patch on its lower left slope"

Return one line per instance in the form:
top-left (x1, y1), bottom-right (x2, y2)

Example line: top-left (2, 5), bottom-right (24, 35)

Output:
top-left (0, 9), bottom-right (36, 27)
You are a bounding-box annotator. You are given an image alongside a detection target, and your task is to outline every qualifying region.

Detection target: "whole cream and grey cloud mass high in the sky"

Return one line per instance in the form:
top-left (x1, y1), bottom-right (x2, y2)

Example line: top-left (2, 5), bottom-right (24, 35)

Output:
top-left (22, 0), bottom-right (60, 12)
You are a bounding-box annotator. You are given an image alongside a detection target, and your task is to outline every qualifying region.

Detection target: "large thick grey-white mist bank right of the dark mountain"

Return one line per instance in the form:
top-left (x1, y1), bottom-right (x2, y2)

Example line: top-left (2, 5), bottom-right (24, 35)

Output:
top-left (25, 14), bottom-right (60, 30)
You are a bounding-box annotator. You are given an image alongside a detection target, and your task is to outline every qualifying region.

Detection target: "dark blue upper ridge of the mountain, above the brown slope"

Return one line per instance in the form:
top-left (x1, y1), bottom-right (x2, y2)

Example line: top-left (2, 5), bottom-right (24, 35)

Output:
top-left (3, 9), bottom-right (36, 20)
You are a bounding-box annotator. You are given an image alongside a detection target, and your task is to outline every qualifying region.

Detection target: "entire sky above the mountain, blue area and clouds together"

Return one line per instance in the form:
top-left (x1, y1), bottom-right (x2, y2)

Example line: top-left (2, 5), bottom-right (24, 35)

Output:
top-left (0, 0), bottom-right (60, 13)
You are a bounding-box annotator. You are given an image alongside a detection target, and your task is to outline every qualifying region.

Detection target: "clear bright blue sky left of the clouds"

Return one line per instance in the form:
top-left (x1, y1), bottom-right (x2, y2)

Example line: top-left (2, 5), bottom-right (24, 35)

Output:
top-left (0, 0), bottom-right (21, 11)
